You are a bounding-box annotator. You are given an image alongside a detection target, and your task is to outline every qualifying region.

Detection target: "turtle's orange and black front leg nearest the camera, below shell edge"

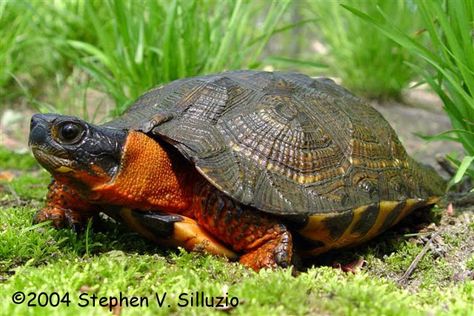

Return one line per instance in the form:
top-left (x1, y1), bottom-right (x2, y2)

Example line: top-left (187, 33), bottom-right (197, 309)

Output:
top-left (194, 184), bottom-right (293, 271)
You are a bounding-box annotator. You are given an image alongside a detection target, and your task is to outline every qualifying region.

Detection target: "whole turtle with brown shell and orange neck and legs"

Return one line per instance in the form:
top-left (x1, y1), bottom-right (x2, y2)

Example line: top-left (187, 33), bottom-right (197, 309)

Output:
top-left (29, 70), bottom-right (445, 271)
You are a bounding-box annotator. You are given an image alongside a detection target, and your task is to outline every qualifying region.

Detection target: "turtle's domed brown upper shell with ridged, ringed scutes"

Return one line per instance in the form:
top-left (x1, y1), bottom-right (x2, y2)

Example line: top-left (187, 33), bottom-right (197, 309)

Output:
top-left (106, 71), bottom-right (443, 217)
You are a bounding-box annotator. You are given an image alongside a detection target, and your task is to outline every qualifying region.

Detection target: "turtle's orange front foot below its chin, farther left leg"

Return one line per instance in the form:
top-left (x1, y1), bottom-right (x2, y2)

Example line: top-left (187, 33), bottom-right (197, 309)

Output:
top-left (33, 180), bottom-right (93, 230)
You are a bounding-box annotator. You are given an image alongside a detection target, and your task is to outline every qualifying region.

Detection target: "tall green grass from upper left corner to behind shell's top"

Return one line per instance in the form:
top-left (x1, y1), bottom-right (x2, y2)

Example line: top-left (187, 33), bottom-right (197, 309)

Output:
top-left (0, 0), bottom-right (290, 116)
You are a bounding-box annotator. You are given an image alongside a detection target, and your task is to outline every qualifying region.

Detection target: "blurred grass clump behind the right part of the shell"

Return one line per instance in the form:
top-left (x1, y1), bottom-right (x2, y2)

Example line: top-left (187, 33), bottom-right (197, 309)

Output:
top-left (307, 0), bottom-right (419, 99)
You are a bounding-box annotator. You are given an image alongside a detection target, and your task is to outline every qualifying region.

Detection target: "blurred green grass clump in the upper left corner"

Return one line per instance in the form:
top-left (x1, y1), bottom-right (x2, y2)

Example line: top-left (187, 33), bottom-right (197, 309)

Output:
top-left (0, 0), bottom-right (93, 110)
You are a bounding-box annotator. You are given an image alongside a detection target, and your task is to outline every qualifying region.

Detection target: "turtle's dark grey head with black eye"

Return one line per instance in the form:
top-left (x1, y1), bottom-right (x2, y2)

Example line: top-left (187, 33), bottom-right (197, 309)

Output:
top-left (29, 114), bottom-right (127, 187)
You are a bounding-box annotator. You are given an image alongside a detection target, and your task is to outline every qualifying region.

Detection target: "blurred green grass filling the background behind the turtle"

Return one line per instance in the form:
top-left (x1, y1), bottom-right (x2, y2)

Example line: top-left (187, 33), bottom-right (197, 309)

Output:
top-left (0, 0), bottom-right (474, 179)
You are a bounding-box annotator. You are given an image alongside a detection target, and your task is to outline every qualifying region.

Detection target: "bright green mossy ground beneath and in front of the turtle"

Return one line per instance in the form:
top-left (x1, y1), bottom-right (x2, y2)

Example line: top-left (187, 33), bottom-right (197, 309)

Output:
top-left (0, 151), bottom-right (474, 315)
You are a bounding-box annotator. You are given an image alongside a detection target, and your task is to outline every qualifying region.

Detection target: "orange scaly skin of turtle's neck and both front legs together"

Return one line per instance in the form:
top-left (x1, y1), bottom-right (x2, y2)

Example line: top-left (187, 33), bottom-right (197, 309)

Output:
top-left (36, 131), bottom-right (292, 270)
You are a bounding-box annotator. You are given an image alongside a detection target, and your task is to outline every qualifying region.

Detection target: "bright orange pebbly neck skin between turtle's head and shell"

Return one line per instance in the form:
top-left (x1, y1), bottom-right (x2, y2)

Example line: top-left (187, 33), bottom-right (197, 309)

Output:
top-left (89, 131), bottom-right (199, 214)
